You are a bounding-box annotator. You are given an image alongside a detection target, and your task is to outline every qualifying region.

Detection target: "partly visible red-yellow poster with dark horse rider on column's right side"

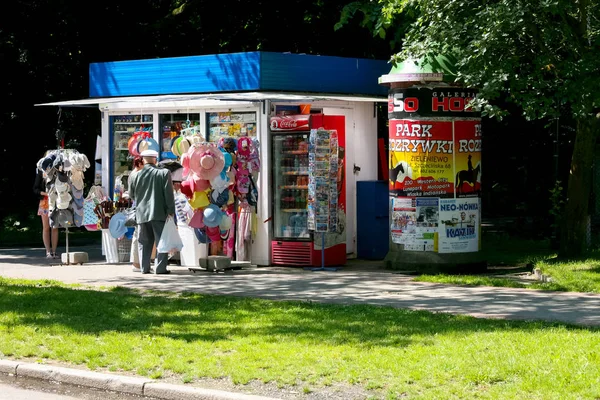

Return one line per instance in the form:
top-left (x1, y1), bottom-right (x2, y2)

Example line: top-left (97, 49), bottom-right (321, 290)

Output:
top-left (454, 119), bottom-right (481, 197)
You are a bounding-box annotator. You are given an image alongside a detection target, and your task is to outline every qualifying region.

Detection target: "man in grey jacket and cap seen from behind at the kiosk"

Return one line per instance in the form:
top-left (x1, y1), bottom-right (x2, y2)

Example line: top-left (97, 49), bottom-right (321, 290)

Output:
top-left (129, 150), bottom-right (175, 274)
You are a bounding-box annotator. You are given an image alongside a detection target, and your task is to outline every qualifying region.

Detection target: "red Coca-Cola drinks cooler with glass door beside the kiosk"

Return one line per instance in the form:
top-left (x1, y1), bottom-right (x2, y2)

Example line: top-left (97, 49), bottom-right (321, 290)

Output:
top-left (270, 114), bottom-right (346, 266)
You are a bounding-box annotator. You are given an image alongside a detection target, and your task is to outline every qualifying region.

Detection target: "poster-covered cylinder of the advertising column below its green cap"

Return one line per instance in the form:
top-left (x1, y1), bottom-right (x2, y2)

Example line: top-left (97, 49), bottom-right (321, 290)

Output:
top-left (386, 87), bottom-right (482, 269)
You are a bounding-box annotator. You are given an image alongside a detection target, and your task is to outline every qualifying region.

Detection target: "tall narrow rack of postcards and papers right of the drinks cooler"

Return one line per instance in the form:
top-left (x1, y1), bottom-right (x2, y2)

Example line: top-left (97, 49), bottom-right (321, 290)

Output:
top-left (308, 129), bottom-right (338, 232)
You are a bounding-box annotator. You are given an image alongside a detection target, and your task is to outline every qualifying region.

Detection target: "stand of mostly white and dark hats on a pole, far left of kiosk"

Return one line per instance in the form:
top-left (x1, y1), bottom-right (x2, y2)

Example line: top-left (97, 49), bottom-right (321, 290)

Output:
top-left (37, 148), bottom-right (90, 265)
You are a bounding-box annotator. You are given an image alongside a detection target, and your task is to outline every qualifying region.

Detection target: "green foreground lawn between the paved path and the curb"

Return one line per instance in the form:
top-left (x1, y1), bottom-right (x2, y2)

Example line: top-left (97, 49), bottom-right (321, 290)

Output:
top-left (0, 278), bottom-right (600, 400)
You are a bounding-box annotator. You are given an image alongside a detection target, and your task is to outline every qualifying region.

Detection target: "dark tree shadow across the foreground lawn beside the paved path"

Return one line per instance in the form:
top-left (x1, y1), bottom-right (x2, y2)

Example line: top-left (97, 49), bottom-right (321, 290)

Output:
top-left (0, 280), bottom-right (589, 347)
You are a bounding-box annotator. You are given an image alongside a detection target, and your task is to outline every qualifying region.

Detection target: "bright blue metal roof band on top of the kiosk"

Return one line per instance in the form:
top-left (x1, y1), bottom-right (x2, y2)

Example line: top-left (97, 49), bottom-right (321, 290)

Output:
top-left (90, 52), bottom-right (390, 97)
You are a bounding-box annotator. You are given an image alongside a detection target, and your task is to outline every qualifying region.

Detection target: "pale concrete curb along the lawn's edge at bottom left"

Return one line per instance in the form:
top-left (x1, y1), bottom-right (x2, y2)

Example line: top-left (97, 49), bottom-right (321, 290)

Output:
top-left (0, 359), bottom-right (278, 400)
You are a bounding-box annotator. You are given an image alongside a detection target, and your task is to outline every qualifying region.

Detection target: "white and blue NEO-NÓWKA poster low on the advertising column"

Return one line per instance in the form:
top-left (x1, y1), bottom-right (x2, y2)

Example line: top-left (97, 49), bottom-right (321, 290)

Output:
top-left (438, 198), bottom-right (481, 253)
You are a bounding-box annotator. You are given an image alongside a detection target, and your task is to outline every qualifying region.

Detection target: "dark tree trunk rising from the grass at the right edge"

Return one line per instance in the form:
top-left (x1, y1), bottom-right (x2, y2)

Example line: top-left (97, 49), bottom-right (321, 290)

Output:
top-left (559, 117), bottom-right (597, 258)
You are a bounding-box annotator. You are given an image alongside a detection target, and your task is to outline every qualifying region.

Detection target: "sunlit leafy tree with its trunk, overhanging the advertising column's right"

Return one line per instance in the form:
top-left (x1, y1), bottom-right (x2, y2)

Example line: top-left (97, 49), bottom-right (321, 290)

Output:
top-left (342, 0), bottom-right (600, 255)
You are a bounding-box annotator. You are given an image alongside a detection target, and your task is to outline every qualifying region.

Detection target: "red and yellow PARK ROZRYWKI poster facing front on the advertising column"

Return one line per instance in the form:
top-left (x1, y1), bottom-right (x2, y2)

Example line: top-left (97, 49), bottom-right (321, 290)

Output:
top-left (389, 119), bottom-right (454, 197)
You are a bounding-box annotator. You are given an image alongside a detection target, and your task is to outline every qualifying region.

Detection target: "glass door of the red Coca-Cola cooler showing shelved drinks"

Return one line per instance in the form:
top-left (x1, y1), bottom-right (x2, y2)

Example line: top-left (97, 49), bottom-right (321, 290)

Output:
top-left (272, 132), bottom-right (310, 240)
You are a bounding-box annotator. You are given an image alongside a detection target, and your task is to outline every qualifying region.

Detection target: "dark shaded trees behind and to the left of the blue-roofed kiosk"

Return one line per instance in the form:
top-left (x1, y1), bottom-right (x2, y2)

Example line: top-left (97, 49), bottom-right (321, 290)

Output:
top-left (0, 0), bottom-right (389, 223)
